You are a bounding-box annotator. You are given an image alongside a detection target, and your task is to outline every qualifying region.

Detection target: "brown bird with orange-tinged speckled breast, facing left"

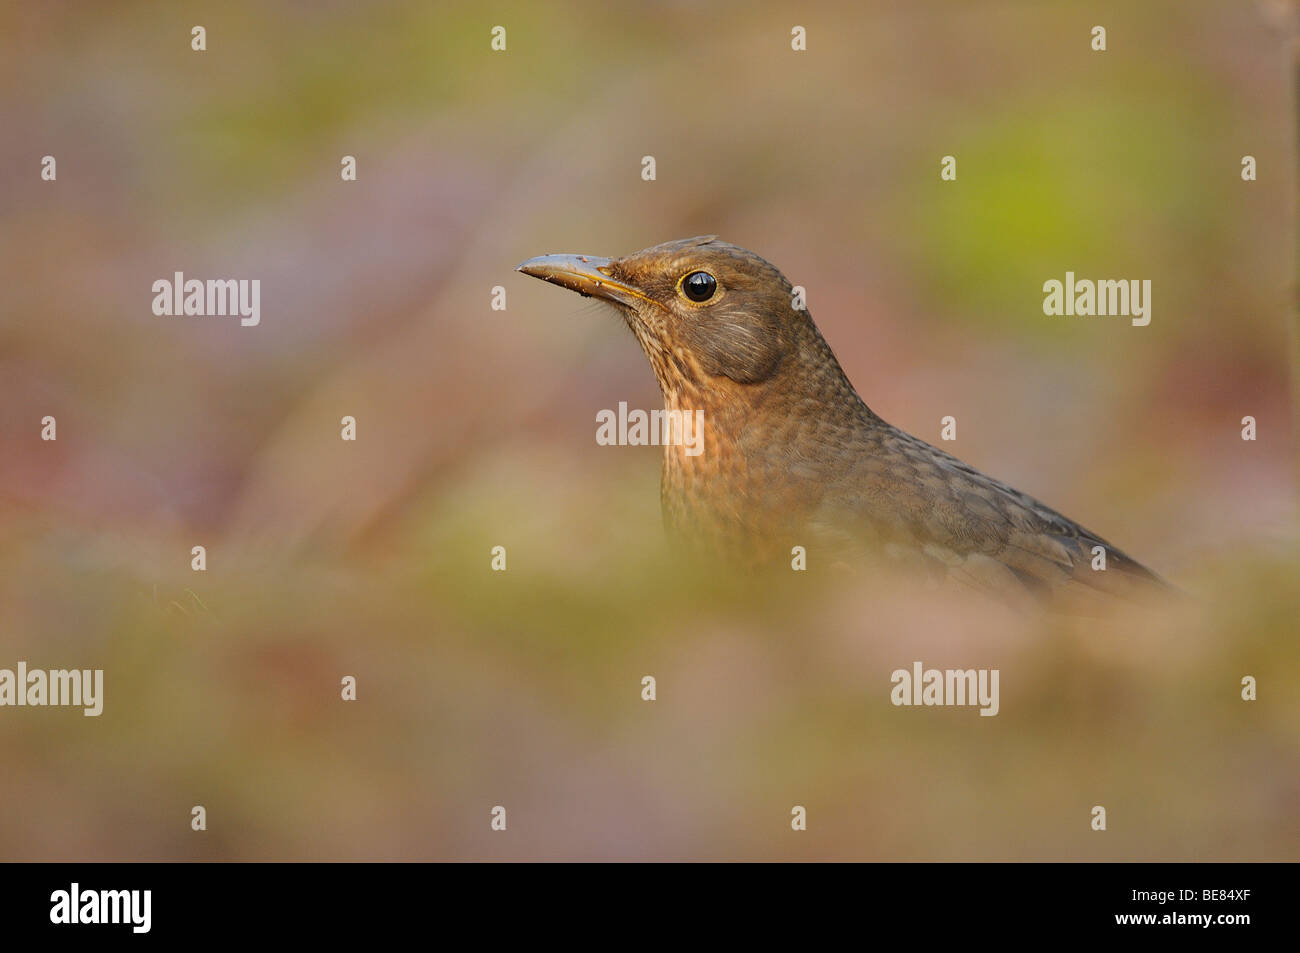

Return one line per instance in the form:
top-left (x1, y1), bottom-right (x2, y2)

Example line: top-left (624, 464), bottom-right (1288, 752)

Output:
top-left (517, 235), bottom-right (1165, 594)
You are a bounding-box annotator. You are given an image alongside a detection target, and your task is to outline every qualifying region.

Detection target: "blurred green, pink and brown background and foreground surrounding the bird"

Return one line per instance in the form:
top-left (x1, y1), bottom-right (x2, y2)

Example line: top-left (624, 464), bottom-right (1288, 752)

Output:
top-left (0, 0), bottom-right (1300, 861)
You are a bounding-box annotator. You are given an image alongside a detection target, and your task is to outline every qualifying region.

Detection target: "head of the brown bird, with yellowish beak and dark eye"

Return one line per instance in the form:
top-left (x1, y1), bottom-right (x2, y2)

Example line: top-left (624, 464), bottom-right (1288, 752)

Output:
top-left (516, 235), bottom-right (839, 398)
